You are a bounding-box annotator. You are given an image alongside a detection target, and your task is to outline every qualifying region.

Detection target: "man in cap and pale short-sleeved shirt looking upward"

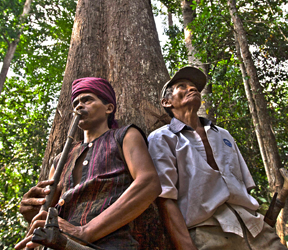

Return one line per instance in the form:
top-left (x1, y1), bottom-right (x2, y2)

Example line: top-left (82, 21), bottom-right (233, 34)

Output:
top-left (148, 66), bottom-right (286, 250)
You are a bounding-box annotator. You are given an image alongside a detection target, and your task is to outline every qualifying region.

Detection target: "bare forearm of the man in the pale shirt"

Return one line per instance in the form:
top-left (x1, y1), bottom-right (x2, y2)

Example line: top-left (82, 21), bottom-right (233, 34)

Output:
top-left (157, 198), bottom-right (197, 250)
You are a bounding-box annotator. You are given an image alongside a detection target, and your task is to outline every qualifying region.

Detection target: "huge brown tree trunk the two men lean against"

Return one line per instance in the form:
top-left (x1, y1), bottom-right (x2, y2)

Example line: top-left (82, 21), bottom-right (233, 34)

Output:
top-left (40, 0), bottom-right (169, 249)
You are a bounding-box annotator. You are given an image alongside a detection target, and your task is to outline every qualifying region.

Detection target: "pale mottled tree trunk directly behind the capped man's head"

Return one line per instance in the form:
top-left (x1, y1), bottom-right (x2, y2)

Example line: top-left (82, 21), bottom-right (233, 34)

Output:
top-left (181, 0), bottom-right (214, 122)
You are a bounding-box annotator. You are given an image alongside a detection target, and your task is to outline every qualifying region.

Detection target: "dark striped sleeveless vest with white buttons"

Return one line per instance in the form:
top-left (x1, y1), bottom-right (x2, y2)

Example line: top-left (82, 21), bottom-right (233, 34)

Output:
top-left (54, 125), bottom-right (170, 250)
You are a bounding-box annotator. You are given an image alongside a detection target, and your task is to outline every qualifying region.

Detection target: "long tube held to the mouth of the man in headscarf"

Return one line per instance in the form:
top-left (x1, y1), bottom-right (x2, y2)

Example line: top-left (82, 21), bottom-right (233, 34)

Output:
top-left (26, 111), bottom-right (81, 250)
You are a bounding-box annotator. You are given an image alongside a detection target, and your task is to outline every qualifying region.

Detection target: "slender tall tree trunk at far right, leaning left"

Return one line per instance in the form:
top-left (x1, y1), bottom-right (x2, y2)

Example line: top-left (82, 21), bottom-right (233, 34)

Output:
top-left (228, 0), bottom-right (287, 244)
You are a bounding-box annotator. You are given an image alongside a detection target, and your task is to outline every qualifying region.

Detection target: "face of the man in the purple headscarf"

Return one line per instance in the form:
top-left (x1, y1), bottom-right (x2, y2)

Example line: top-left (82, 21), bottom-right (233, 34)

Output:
top-left (72, 93), bottom-right (114, 130)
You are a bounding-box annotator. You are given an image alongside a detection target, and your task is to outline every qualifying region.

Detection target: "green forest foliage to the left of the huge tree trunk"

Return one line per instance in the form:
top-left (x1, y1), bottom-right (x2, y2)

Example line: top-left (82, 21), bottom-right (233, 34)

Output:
top-left (0, 0), bottom-right (76, 246)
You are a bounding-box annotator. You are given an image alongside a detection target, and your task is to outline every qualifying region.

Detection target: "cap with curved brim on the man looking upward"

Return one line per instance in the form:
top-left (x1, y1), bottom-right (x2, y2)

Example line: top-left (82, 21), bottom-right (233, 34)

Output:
top-left (161, 66), bottom-right (207, 98)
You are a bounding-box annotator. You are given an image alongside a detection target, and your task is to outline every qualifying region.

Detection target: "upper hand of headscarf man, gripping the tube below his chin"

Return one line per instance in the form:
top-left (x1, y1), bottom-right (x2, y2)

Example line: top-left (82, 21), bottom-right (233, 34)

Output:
top-left (19, 180), bottom-right (54, 223)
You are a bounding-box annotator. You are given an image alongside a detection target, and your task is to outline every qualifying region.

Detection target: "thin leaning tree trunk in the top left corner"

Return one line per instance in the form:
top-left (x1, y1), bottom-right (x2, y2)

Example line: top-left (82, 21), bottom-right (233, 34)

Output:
top-left (0, 0), bottom-right (32, 94)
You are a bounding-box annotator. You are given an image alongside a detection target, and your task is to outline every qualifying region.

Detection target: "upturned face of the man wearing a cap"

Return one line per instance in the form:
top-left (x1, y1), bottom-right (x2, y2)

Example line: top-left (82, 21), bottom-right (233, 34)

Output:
top-left (165, 79), bottom-right (201, 110)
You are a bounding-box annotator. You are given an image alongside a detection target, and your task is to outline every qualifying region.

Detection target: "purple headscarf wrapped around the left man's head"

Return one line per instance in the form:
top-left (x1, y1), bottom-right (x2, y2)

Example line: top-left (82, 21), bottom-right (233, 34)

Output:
top-left (71, 77), bottom-right (118, 128)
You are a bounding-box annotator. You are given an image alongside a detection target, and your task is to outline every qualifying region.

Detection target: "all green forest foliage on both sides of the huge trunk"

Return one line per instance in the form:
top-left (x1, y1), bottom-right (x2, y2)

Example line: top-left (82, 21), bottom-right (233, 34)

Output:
top-left (0, 0), bottom-right (288, 249)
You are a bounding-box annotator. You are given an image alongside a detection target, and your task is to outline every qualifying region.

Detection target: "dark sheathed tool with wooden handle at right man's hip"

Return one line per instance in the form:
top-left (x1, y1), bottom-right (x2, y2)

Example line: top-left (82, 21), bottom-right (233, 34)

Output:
top-left (264, 168), bottom-right (288, 227)
